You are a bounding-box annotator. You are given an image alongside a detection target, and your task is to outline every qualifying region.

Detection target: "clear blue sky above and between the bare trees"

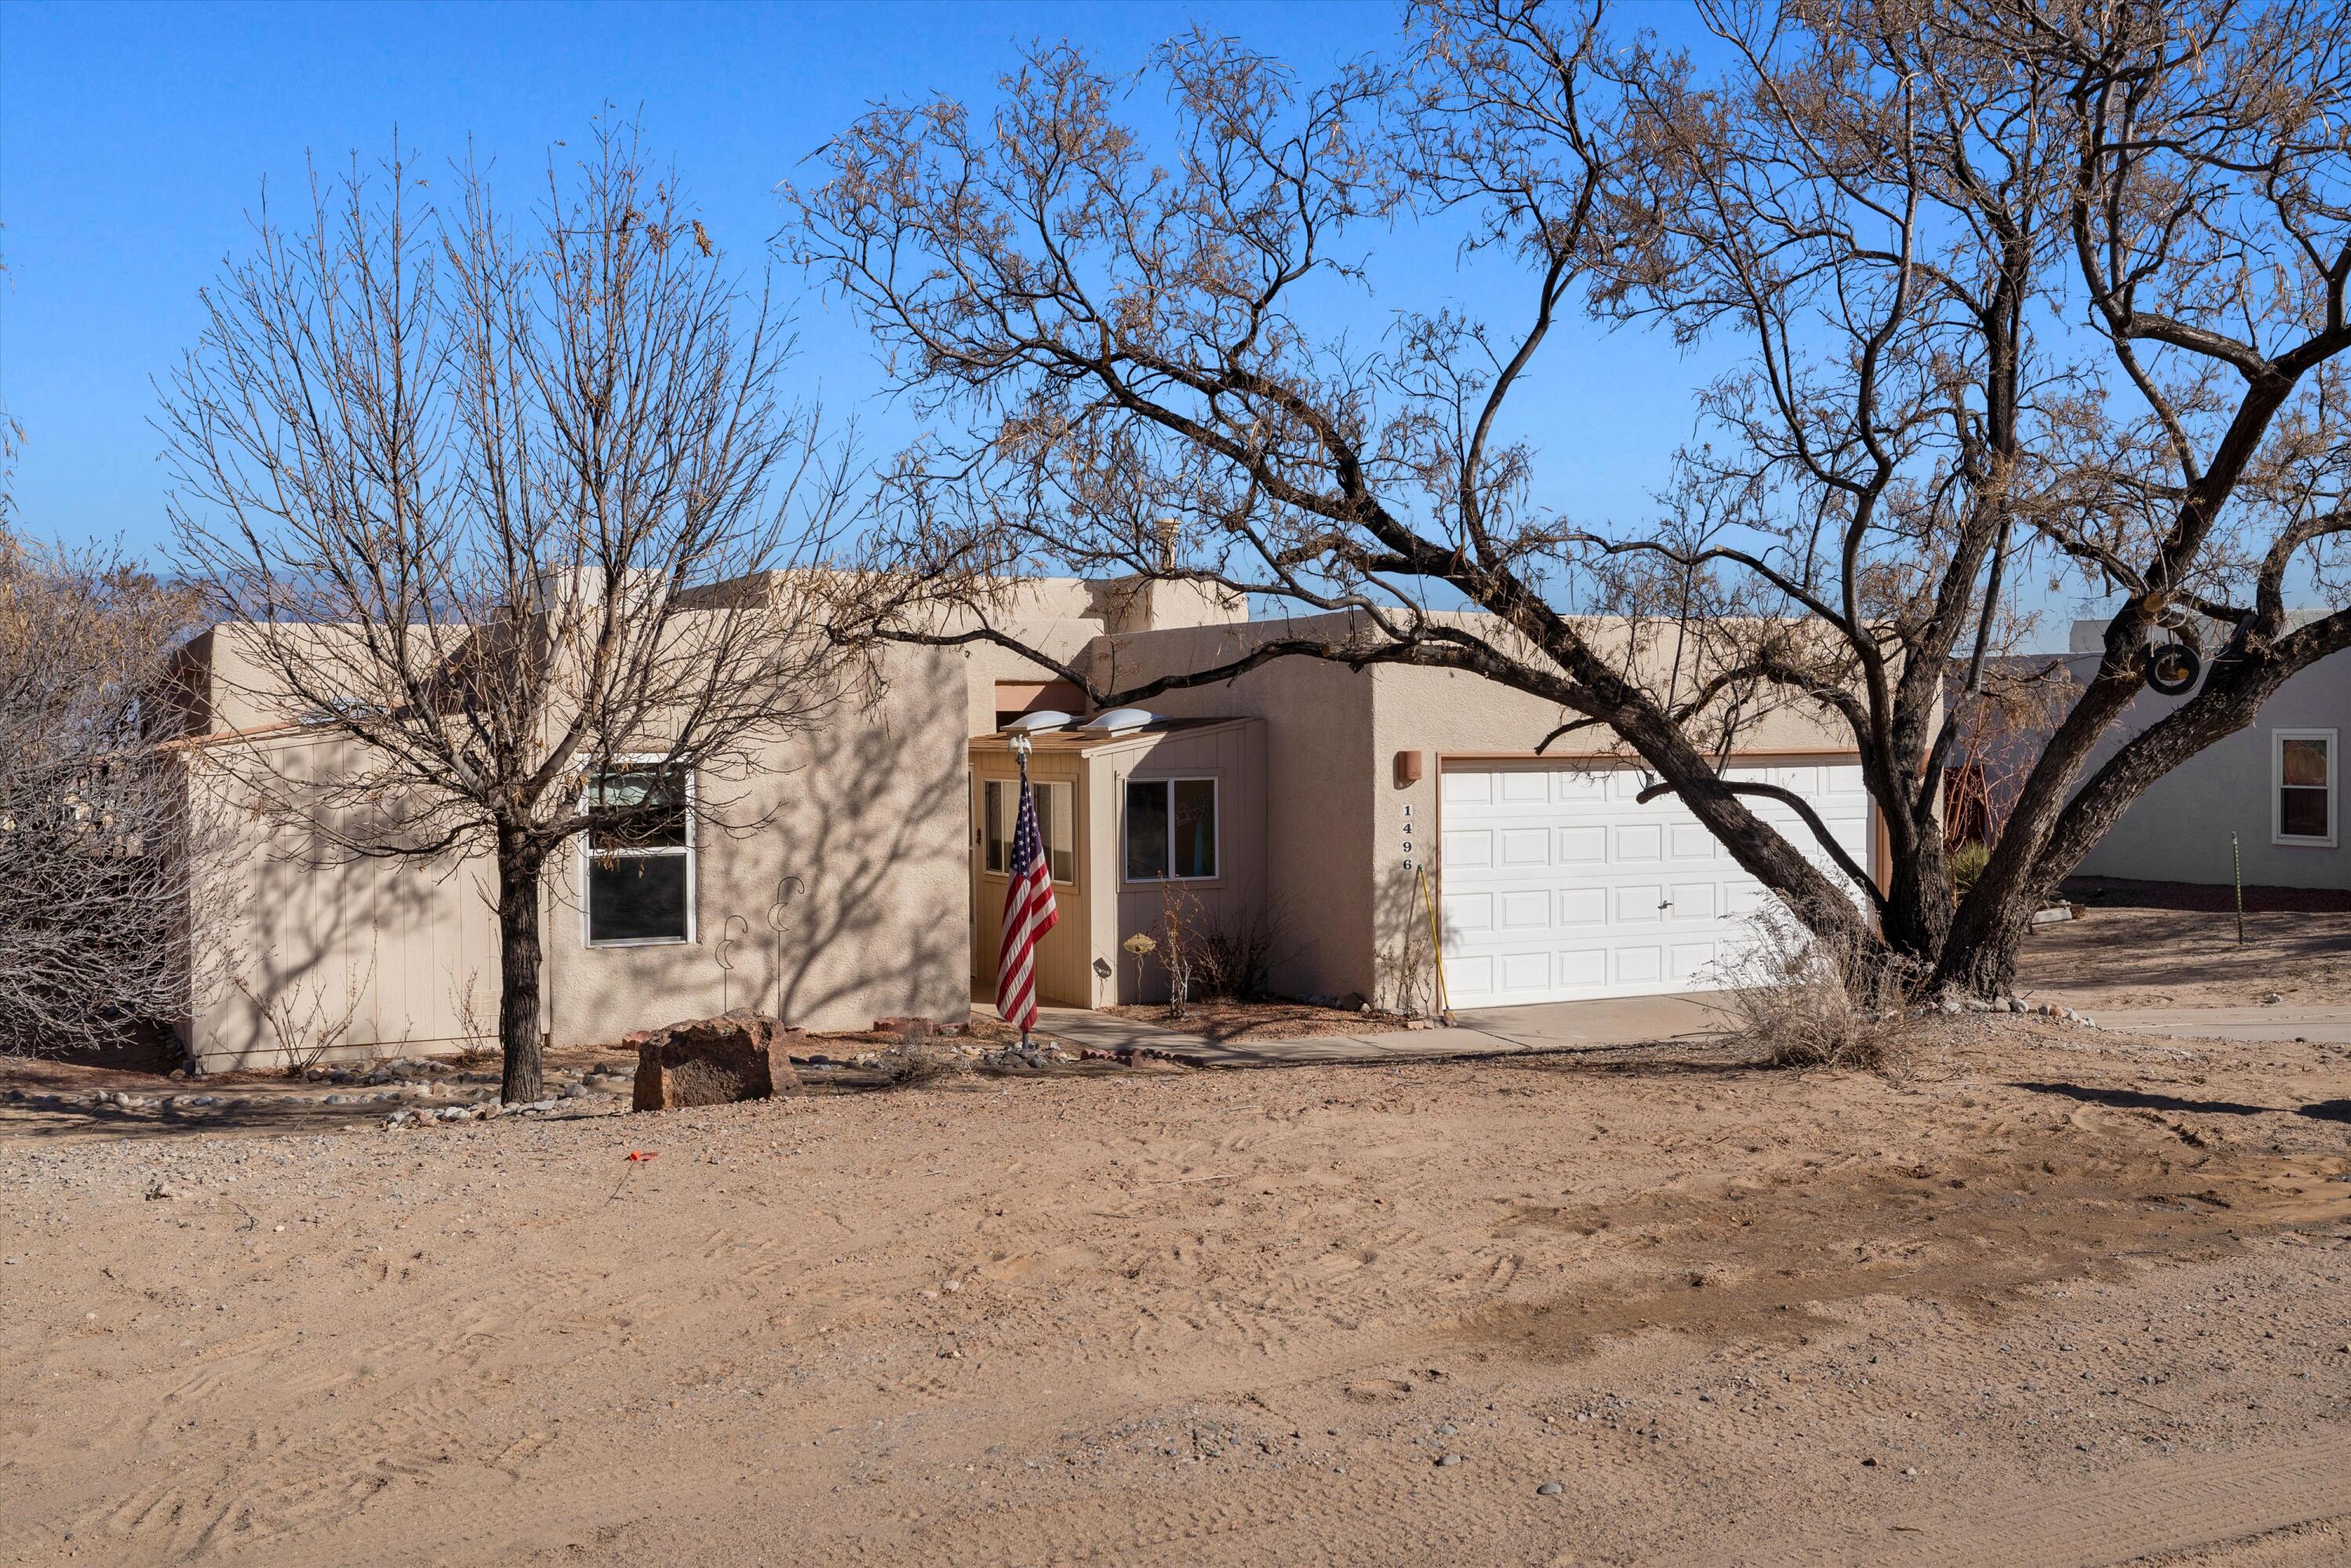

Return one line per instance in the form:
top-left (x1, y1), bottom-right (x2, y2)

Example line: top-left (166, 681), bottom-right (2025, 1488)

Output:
top-left (0, 0), bottom-right (1749, 576)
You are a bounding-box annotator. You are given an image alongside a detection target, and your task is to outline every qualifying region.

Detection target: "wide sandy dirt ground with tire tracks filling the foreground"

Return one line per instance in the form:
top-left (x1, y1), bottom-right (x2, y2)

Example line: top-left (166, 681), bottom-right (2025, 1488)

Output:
top-left (0, 1011), bottom-right (2351, 1568)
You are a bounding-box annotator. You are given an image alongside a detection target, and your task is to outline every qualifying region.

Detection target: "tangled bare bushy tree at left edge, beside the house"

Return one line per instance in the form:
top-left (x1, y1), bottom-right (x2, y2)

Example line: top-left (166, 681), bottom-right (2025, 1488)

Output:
top-left (0, 529), bottom-right (221, 1053)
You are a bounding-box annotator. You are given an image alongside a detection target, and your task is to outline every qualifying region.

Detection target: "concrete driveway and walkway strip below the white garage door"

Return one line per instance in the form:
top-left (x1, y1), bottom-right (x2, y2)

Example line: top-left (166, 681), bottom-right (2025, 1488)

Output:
top-left (1037, 992), bottom-right (1726, 1067)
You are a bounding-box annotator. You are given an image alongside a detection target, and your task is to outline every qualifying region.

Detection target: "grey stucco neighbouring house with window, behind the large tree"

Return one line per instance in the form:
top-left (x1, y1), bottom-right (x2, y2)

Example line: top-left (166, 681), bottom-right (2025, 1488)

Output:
top-left (1947, 611), bottom-right (2351, 889)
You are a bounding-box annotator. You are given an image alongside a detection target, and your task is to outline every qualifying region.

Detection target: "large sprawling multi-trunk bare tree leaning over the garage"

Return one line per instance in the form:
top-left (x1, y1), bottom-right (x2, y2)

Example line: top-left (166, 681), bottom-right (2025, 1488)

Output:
top-left (785, 0), bottom-right (2351, 990)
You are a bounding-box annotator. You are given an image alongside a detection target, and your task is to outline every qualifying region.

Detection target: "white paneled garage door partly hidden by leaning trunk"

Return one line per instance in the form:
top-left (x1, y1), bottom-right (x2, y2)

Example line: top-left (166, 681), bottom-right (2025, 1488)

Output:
top-left (1439, 764), bottom-right (1869, 1009)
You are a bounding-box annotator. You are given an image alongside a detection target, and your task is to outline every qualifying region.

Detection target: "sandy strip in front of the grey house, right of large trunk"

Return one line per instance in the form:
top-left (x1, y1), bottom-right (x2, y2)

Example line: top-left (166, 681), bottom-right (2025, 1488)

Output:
top-left (2017, 905), bottom-right (2351, 1016)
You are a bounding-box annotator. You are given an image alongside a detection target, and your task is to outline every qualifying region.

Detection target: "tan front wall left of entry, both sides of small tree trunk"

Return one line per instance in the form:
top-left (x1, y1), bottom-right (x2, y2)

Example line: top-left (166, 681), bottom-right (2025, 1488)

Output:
top-left (174, 642), bottom-right (969, 1070)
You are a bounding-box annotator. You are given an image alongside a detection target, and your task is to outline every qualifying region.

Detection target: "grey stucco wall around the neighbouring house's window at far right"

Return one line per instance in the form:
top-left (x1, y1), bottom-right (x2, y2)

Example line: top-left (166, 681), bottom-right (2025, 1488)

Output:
top-left (2074, 654), bottom-right (2351, 889)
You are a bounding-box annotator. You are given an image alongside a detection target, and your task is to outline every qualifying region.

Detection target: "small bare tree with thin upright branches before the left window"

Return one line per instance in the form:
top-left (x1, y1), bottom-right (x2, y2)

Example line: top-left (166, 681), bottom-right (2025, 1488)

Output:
top-left (165, 125), bottom-right (865, 1100)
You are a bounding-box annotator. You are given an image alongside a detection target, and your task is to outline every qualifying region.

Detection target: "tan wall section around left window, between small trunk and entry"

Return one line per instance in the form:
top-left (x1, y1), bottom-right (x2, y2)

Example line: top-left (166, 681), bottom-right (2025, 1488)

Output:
top-left (545, 646), bottom-right (971, 1046)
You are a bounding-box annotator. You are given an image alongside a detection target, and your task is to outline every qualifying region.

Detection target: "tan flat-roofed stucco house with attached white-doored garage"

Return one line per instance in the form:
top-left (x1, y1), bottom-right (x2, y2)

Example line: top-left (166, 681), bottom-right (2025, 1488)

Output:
top-left (186, 578), bottom-right (1881, 1067)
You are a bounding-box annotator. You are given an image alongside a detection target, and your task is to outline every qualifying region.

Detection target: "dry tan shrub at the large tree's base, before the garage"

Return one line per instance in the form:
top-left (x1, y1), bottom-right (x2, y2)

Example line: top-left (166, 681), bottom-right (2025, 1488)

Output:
top-left (1728, 914), bottom-right (1921, 1072)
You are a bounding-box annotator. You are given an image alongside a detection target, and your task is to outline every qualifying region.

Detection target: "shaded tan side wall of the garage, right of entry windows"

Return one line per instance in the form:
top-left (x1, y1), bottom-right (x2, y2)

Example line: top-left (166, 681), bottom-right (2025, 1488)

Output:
top-left (1093, 616), bottom-right (1375, 997)
